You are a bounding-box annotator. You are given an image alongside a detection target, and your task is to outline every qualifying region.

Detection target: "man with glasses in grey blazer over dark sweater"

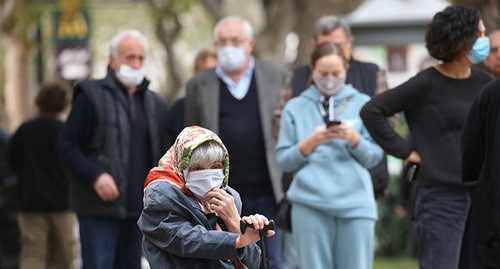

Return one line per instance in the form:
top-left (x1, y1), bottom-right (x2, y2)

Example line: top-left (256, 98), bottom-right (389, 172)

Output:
top-left (185, 16), bottom-right (287, 268)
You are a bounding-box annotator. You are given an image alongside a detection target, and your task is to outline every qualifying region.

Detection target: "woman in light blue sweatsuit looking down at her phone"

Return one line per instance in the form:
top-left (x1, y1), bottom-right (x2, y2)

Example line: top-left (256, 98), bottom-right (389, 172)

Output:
top-left (276, 43), bottom-right (383, 269)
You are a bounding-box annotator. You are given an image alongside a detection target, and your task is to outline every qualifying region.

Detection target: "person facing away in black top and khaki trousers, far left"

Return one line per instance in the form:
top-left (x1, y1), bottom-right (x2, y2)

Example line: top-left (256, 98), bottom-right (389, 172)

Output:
top-left (8, 82), bottom-right (79, 269)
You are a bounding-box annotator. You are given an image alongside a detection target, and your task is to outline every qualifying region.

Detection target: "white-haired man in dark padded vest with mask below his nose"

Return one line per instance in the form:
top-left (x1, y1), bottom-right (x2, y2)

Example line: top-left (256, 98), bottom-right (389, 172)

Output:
top-left (58, 30), bottom-right (167, 269)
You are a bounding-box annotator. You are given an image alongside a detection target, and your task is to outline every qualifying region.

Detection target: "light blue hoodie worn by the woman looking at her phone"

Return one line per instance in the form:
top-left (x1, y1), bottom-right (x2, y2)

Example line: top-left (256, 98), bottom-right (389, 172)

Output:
top-left (276, 84), bottom-right (383, 219)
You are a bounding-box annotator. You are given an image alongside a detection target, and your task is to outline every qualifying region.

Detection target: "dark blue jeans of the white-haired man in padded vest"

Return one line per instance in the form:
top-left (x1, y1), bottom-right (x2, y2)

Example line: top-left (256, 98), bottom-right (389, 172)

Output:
top-left (78, 216), bottom-right (142, 269)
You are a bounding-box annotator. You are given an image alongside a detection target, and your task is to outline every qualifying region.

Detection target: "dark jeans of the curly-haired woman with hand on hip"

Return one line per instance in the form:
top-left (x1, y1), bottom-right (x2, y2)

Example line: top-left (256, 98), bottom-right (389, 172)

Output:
top-left (414, 186), bottom-right (470, 269)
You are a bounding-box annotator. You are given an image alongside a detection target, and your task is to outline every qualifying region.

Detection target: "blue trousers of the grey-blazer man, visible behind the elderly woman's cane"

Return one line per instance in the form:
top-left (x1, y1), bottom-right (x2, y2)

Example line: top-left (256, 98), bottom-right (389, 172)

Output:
top-left (241, 195), bottom-right (281, 269)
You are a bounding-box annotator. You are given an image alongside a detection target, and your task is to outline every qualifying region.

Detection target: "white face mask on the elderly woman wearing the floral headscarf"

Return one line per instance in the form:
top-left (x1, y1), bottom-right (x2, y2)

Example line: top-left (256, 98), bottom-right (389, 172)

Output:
top-left (186, 169), bottom-right (224, 202)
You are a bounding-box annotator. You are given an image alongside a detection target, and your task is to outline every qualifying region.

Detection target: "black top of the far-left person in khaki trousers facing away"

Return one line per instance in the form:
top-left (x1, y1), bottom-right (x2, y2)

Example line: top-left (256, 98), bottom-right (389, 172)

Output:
top-left (8, 117), bottom-right (70, 212)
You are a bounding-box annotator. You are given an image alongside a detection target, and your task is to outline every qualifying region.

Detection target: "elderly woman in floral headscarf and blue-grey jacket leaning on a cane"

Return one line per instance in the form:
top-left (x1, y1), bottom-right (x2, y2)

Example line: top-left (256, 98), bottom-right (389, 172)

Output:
top-left (137, 126), bottom-right (274, 269)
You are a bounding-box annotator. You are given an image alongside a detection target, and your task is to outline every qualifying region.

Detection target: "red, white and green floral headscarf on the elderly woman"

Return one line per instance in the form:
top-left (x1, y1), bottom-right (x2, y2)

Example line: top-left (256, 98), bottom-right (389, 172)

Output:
top-left (144, 126), bottom-right (229, 191)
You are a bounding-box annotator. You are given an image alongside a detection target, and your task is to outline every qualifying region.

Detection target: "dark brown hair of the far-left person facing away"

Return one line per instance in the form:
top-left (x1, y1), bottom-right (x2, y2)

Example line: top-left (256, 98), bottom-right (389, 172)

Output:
top-left (35, 81), bottom-right (71, 114)
